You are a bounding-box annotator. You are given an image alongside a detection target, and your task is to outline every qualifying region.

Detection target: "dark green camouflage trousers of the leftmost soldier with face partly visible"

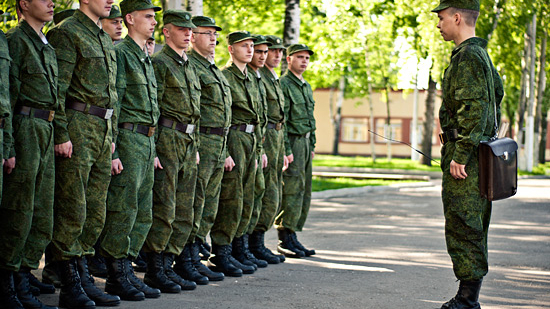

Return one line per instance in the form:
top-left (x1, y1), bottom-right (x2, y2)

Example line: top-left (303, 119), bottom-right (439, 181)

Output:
top-left (0, 115), bottom-right (55, 271)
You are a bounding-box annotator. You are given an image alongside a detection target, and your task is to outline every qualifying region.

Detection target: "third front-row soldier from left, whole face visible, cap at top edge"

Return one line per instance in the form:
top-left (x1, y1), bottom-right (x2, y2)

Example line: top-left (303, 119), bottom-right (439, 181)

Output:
top-left (101, 0), bottom-right (162, 301)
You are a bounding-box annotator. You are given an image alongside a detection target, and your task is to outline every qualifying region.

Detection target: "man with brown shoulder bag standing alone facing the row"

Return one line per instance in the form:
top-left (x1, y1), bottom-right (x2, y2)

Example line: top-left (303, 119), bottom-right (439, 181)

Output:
top-left (432, 0), bottom-right (504, 309)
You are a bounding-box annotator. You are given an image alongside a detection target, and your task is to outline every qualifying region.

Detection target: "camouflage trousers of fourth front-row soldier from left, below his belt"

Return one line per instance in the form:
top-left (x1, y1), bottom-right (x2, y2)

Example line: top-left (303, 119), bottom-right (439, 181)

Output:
top-left (143, 127), bottom-right (197, 255)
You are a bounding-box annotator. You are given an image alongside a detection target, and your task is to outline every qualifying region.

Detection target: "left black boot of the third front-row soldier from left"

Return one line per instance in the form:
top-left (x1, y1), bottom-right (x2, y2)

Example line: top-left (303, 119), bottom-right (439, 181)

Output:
top-left (105, 258), bottom-right (145, 301)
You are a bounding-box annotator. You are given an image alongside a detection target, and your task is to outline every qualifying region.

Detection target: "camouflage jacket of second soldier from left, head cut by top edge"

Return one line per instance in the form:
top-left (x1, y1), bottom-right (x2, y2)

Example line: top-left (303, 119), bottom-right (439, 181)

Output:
top-left (47, 10), bottom-right (117, 144)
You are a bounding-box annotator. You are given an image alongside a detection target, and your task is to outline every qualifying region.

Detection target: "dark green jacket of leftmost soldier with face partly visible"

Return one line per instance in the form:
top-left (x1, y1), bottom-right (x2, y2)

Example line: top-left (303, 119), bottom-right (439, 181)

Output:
top-left (4, 20), bottom-right (58, 157)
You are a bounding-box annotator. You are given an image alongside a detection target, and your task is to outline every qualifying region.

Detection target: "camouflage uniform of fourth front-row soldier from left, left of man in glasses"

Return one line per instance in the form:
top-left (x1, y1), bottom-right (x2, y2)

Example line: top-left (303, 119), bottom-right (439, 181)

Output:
top-left (144, 45), bottom-right (200, 255)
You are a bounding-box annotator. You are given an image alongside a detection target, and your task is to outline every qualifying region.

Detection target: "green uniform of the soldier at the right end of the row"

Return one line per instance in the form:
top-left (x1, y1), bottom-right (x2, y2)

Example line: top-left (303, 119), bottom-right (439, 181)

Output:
top-left (275, 71), bottom-right (316, 232)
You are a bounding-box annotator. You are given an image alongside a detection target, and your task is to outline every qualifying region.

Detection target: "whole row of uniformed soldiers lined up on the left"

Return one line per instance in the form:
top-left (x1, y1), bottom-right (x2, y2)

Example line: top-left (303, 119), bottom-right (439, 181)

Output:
top-left (0, 0), bottom-right (315, 308)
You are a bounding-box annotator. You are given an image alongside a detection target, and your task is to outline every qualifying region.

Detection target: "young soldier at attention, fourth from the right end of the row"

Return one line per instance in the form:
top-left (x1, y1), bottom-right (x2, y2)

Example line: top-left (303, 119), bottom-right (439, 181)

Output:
top-left (210, 31), bottom-right (261, 275)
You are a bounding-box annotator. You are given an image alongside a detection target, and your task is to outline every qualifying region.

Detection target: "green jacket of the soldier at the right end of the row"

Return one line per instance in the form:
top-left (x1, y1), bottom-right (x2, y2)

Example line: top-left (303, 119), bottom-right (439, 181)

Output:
top-left (281, 70), bottom-right (316, 155)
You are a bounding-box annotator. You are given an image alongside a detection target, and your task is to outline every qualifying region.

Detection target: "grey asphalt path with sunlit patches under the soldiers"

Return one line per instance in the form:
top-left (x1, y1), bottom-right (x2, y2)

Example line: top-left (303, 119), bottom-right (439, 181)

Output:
top-left (37, 179), bottom-right (550, 309)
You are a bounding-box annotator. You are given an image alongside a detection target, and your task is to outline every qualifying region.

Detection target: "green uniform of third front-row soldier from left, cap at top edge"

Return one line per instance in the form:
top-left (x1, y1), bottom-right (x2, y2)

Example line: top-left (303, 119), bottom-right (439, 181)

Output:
top-left (101, 36), bottom-right (160, 259)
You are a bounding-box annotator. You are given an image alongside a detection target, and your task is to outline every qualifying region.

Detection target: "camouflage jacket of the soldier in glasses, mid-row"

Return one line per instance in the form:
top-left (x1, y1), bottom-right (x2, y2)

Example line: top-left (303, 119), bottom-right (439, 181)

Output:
top-left (189, 50), bottom-right (231, 128)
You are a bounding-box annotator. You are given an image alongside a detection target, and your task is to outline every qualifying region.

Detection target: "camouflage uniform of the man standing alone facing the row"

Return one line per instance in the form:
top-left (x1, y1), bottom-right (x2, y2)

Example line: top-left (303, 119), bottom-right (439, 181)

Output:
top-left (439, 37), bottom-right (503, 281)
